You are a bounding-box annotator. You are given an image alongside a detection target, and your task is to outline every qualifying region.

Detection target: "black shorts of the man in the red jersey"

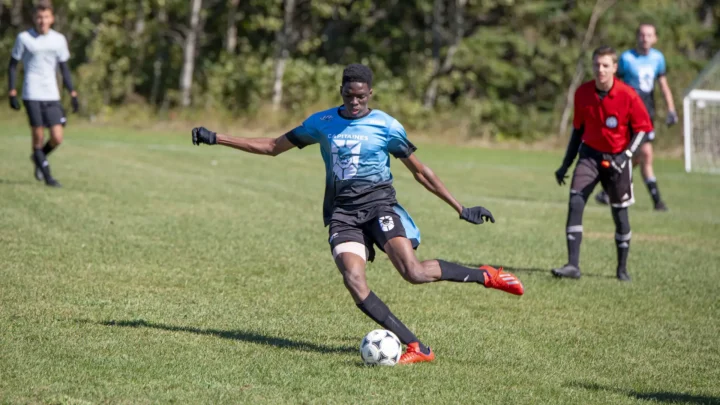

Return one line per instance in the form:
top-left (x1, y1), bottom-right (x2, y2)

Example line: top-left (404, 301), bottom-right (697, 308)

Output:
top-left (570, 144), bottom-right (635, 208)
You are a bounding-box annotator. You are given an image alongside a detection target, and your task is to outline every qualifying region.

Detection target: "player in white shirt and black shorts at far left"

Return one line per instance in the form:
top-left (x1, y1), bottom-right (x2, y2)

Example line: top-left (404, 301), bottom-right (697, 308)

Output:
top-left (8, 0), bottom-right (78, 187)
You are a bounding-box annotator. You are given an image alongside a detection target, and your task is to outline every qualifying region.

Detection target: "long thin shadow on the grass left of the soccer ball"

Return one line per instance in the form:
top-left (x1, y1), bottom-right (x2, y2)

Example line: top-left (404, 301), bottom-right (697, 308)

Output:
top-left (99, 319), bottom-right (358, 354)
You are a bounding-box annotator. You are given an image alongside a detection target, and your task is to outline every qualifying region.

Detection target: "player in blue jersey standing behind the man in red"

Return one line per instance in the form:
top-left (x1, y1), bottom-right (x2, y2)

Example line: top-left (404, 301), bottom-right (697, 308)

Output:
top-left (595, 23), bottom-right (678, 211)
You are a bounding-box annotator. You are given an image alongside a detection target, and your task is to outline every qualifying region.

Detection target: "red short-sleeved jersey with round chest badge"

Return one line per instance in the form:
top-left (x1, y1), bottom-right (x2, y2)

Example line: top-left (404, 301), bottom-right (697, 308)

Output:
top-left (573, 79), bottom-right (653, 153)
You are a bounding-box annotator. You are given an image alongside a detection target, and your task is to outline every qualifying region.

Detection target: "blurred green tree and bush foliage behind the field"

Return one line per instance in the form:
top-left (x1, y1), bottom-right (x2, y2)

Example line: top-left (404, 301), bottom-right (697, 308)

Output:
top-left (0, 0), bottom-right (720, 140)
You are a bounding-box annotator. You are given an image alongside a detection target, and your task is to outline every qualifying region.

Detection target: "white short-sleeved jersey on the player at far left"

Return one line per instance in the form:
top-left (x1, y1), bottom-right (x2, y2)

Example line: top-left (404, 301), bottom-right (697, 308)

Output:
top-left (12, 29), bottom-right (70, 101)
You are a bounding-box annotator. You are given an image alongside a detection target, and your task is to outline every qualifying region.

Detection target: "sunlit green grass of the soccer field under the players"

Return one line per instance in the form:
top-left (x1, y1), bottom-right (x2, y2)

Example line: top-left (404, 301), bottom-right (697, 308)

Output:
top-left (0, 125), bottom-right (720, 404)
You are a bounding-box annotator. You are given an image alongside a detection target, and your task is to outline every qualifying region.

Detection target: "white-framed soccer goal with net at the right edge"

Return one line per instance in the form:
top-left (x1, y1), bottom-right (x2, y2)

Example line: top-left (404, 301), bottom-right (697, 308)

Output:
top-left (683, 52), bottom-right (720, 173)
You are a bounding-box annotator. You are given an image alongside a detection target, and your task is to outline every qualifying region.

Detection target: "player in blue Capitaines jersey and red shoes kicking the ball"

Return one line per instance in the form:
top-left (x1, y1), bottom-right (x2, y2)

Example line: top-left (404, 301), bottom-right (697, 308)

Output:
top-left (192, 64), bottom-right (524, 364)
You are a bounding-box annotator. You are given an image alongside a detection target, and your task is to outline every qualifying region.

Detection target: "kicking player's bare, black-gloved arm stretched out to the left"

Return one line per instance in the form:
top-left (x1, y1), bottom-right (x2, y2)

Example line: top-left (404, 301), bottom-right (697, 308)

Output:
top-left (192, 127), bottom-right (295, 156)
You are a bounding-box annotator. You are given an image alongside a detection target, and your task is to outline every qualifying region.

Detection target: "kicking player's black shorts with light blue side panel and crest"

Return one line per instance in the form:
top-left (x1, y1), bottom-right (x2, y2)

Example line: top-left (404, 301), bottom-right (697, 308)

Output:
top-left (328, 207), bottom-right (420, 262)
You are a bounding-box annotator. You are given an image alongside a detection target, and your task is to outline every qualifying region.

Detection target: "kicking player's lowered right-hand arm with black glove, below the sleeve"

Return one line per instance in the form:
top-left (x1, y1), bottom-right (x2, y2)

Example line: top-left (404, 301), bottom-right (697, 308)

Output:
top-left (400, 154), bottom-right (495, 224)
